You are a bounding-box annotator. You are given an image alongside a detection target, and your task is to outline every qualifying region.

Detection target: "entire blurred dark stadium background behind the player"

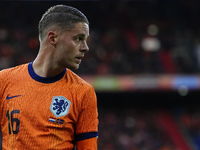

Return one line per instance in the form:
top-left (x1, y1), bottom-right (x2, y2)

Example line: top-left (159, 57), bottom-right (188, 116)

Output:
top-left (0, 0), bottom-right (200, 150)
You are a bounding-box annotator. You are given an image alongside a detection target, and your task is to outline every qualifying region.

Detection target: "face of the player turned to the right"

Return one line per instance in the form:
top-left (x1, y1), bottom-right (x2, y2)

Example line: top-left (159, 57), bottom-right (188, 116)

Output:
top-left (56, 22), bottom-right (89, 70)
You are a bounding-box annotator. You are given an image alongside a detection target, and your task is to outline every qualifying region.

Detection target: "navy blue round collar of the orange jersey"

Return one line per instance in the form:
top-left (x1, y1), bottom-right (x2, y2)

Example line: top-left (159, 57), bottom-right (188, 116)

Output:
top-left (28, 62), bottom-right (66, 83)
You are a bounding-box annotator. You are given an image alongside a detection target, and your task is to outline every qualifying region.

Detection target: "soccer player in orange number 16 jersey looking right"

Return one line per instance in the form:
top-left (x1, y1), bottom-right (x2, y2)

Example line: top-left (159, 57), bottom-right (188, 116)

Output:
top-left (0, 5), bottom-right (98, 150)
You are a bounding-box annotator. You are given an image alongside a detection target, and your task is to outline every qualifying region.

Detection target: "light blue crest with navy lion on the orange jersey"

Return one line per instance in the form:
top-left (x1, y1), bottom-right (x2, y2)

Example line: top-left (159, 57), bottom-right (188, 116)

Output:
top-left (50, 96), bottom-right (71, 117)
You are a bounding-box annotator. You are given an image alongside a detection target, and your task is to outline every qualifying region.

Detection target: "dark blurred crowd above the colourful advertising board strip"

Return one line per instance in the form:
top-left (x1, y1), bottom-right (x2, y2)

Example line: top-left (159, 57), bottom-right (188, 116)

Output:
top-left (0, 0), bottom-right (200, 75)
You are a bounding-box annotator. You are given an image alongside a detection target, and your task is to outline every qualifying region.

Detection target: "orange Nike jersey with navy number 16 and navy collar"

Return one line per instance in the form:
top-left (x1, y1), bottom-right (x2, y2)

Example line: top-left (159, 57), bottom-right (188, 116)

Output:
top-left (0, 63), bottom-right (98, 150)
